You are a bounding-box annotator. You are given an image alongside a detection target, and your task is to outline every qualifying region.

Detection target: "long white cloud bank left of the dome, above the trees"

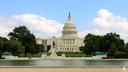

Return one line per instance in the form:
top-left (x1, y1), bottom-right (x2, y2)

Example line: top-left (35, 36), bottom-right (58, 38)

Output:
top-left (0, 14), bottom-right (63, 38)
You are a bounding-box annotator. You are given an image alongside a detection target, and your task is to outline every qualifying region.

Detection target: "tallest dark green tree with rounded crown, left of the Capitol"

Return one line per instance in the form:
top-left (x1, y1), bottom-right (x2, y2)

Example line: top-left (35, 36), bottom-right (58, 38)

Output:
top-left (8, 26), bottom-right (36, 57)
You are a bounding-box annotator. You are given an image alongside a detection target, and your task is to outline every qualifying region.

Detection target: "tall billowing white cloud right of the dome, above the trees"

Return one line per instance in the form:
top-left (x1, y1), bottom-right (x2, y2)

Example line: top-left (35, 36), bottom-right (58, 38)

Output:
top-left (80, 9), bottom-right (128, 41)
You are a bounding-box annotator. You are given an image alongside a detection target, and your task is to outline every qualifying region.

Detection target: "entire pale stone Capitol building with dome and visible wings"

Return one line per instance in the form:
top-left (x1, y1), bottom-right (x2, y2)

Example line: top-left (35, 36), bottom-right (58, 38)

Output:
top-left (37, 13), bottom-right (83, 52)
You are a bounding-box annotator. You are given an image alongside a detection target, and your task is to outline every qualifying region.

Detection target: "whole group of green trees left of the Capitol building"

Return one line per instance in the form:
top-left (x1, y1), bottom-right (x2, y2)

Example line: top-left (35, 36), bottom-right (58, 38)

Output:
top-left (0, 26), bottom-right (44, 57)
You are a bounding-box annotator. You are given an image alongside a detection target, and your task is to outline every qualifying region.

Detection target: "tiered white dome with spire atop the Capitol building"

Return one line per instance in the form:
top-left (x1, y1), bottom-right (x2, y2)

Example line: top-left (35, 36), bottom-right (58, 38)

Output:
top-left (62, 13), bottom-right (77, 38)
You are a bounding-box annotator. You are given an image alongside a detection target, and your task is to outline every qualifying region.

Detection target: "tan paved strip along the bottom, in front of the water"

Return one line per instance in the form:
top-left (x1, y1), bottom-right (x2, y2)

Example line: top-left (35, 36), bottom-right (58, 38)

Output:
top-left (0, 68), bottom-right (128, 72)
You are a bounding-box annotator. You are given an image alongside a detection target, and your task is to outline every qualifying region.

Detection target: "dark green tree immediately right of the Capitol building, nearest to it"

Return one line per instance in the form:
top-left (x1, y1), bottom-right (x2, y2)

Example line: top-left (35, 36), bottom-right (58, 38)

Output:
top-left (84, 34), bottom-right (102, 54)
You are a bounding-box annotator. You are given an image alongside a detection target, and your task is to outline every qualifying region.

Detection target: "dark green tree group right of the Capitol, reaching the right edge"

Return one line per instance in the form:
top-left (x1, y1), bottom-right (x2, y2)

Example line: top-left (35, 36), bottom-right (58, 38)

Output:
top-left (80, 33), bottom-right (128, 58)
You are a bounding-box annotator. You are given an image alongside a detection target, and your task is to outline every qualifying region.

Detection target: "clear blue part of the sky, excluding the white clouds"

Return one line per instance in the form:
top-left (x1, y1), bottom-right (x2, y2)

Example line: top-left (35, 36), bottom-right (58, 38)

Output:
top-left (0, 0), bottom-right (128, 41)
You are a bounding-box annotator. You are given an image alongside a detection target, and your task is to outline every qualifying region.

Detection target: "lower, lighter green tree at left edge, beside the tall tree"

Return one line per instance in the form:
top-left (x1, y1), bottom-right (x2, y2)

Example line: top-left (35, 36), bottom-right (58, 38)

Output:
top-left (0, 37), bottom-right (24, 56)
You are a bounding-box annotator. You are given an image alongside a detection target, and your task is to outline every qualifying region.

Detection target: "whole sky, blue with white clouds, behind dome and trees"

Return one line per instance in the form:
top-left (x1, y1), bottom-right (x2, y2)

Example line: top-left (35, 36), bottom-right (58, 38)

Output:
top-left (0, 0), bottom-right (128, 42)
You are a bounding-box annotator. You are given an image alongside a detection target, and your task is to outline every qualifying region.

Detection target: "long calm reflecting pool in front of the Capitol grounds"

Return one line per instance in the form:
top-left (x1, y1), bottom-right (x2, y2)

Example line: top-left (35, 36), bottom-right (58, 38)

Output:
top-left (0, 59), bottom-right (128, 67)
